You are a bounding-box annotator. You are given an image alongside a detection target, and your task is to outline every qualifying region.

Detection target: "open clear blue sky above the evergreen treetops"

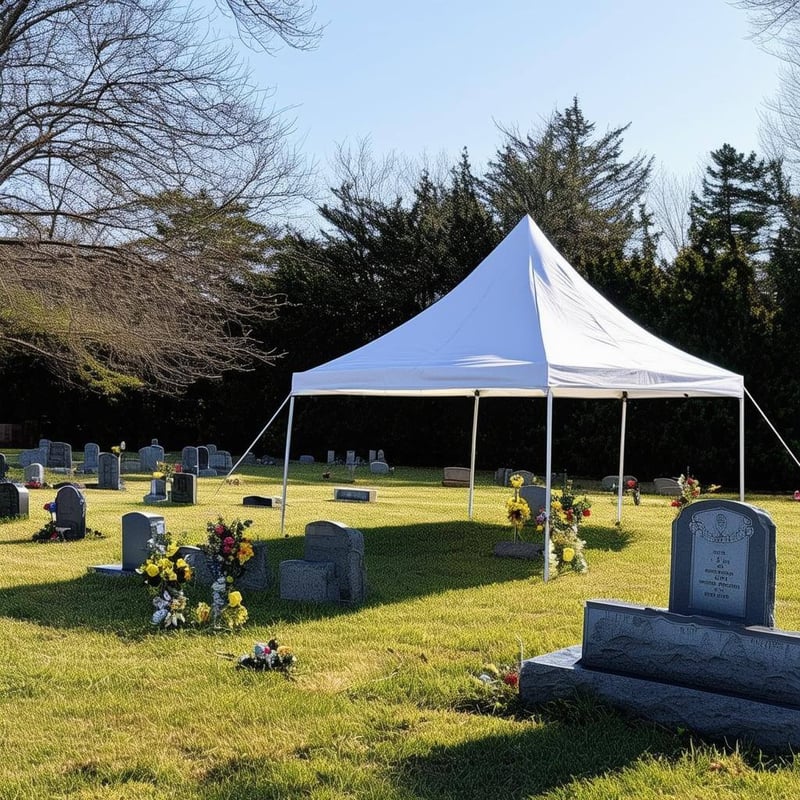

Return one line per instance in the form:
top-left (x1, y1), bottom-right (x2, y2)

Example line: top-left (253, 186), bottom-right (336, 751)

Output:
top-left (216, 0), bottom-right (779, 200)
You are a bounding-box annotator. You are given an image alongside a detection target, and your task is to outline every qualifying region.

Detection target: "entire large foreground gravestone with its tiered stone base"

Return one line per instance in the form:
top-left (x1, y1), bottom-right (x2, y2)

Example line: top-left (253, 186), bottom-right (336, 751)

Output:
top-left (519, 500), bottom-right (800, 750)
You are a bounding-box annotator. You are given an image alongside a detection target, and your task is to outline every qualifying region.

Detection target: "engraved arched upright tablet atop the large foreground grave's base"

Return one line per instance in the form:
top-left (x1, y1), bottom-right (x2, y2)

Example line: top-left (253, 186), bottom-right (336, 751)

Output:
top-left (669, 500), bottom-right (776, 627)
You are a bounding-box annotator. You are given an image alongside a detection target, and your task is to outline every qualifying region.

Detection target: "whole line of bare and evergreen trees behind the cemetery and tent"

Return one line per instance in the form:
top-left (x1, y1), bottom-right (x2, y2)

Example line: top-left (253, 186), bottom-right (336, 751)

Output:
top-left (0, 0), bottom-right (800, 489)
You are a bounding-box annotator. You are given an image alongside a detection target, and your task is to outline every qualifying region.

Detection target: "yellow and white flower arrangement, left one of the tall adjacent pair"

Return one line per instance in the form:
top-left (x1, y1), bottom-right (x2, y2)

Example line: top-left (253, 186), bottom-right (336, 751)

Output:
top-left (136, 532), bottom-right (192, 628)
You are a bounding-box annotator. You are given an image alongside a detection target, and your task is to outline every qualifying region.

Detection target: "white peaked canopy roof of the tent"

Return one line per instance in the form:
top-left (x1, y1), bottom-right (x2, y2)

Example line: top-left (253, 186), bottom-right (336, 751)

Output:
top-left (291, 216), bottom-right (744, 398)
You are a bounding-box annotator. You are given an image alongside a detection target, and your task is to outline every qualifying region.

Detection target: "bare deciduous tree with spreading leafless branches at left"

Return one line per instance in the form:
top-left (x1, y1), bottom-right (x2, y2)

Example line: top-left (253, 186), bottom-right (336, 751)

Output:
top-left (0, 0), bottom-right (317, 391)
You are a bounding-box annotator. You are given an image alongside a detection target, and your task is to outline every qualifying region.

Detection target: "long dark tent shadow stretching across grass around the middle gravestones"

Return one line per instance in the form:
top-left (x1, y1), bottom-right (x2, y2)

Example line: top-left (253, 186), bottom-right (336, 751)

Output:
top-left (0, 521), bottom-right (626, 636)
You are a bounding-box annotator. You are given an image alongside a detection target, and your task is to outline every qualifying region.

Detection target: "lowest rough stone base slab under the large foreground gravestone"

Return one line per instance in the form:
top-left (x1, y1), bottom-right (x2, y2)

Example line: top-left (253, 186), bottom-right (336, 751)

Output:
top-left (519, 645), bottom-right (800, 751)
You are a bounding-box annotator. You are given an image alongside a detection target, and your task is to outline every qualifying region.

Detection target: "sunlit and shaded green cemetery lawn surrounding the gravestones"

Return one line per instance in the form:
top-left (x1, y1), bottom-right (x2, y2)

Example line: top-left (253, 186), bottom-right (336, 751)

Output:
top-left (0, 465), bottom-right (800, 800)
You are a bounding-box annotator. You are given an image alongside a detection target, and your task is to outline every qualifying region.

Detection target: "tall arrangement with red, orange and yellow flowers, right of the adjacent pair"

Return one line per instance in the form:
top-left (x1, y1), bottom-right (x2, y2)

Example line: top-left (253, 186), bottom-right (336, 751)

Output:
top-left (201, 517), bottom-right (253, 629)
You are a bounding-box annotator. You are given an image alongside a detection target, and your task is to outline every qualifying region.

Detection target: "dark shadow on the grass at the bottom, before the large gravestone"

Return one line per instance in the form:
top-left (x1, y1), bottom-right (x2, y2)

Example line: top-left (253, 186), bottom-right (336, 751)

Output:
top-left (390, 712), bottom-right (680, 800)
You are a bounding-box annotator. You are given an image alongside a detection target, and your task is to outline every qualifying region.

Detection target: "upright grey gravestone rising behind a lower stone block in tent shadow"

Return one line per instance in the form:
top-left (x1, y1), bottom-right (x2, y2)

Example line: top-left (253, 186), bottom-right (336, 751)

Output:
top-left (303, 520), bottom-right (367, 603)
